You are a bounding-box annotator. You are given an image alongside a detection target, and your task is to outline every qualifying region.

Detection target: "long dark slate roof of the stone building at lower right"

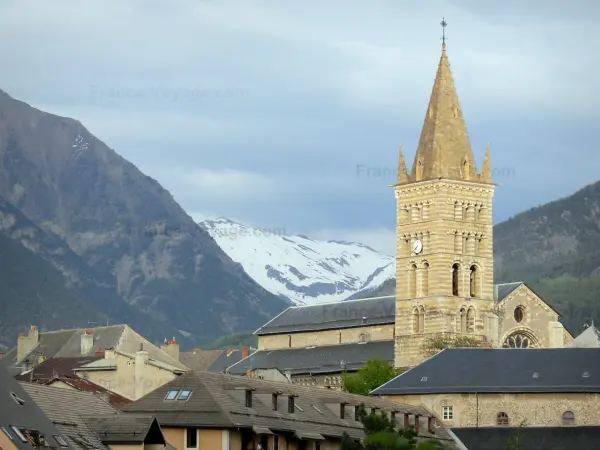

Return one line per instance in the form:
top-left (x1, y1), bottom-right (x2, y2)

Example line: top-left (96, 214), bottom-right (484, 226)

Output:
top-left (372, 348), bottom-right (600, 395)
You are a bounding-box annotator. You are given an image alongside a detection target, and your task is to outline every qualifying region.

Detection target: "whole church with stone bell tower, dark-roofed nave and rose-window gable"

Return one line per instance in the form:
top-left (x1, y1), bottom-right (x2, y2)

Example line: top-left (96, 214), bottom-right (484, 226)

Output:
top-left (228, 40), bottom-right (573, 388)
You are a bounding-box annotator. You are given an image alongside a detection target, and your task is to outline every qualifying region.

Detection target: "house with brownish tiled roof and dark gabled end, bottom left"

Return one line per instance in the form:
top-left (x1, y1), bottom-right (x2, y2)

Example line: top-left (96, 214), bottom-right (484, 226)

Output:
top-left (21, 383), bottom-right (166, 450)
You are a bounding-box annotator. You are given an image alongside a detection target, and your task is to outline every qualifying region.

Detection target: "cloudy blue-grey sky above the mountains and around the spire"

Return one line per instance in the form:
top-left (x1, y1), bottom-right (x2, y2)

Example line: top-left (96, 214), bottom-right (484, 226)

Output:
top-left (0, 0), bottom-right (600, 253)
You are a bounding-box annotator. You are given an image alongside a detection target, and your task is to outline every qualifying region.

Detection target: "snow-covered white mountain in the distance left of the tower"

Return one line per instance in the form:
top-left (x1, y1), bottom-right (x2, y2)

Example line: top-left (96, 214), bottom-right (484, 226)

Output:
top-left (199, 218), bottom-right (395, 305)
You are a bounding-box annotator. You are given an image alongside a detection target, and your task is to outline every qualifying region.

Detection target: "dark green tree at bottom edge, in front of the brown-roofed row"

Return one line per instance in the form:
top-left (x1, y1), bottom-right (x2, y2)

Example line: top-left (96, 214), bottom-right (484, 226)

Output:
top-left (341, 406), bottom-right (444, 450)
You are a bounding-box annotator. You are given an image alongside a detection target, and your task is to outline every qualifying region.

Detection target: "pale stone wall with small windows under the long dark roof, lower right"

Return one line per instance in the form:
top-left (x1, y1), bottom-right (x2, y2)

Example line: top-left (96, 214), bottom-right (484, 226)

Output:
top-left (387, 394), bottom-right (600, 427)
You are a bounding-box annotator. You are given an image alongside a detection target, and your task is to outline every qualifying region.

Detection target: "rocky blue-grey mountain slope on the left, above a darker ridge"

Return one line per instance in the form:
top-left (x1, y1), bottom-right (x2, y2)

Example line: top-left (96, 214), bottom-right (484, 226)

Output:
top-left (0, 91), bottom-right (286, 342)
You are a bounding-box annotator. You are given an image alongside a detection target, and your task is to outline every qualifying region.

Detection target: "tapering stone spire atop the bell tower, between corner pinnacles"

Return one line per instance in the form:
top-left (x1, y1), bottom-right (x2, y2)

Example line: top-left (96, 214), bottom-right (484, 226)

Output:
top-left (411, 38), bottom-right (477, 181)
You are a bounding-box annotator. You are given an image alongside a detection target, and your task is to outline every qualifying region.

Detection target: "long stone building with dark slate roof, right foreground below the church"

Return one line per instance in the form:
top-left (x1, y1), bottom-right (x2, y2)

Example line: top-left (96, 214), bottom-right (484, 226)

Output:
top-left (371, 348), bottom-right (600, 428)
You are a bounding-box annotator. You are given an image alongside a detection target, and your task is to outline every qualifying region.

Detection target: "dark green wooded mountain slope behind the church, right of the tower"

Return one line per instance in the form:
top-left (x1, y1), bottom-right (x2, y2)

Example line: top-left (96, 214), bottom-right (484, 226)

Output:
top-left (361, 182), bottom-right (600, 332)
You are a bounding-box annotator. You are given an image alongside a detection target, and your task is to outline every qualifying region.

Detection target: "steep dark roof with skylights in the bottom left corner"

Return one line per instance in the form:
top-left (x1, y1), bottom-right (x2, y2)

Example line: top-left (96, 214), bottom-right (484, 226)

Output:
top-left (0, 367), bottom-right (74, 450)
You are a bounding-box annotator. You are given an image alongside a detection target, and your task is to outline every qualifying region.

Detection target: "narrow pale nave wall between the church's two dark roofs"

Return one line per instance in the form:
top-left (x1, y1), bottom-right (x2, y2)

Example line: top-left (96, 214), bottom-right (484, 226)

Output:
top-left (258, 324), bottom-right (394, 350)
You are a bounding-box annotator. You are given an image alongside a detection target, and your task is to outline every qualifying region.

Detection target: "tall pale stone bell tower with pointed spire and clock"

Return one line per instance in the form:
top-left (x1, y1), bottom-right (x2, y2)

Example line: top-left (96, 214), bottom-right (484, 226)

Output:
top-left (394, 44), bottom-right (498, 367)
